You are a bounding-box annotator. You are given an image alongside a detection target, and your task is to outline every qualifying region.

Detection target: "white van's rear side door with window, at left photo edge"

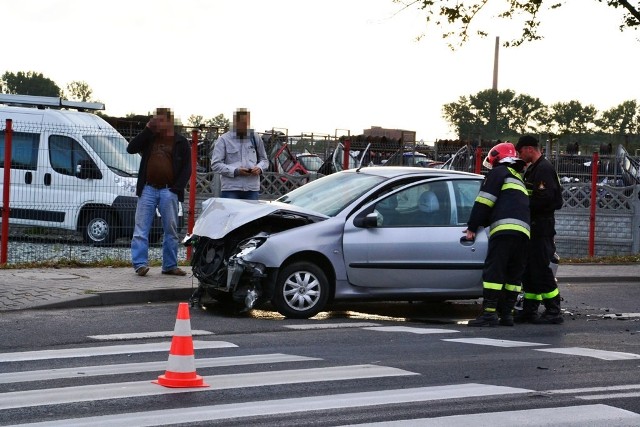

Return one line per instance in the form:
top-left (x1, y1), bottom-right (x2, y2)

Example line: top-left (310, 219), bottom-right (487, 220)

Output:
top-left (0, 130), bottom-right (41, 225)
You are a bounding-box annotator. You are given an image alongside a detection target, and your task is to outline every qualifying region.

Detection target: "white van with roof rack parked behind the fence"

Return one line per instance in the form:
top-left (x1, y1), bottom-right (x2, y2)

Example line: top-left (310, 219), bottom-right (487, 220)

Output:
top-left (0, 94), bottom-right (168, 244)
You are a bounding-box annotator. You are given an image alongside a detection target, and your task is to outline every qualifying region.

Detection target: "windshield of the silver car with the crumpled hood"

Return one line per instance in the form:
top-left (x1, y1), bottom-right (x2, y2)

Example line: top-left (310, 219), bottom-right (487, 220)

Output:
top-left (277, 173), bottom-right (386, 216)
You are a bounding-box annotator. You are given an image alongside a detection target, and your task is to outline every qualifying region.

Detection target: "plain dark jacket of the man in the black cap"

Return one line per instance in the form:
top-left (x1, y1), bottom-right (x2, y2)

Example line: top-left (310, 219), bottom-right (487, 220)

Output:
top-left (524, 156), bottom-right (562, 221)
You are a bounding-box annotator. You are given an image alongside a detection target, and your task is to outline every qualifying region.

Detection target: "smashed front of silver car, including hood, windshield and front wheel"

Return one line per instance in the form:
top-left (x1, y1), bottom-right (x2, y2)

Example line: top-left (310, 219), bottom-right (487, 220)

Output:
top-left (185, 169), bottom-right (386, 318)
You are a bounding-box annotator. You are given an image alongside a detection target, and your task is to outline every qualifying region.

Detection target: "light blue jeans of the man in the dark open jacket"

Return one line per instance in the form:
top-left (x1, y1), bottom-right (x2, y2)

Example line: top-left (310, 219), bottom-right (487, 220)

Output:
top-left (131, 185), bottom-right (178, 271)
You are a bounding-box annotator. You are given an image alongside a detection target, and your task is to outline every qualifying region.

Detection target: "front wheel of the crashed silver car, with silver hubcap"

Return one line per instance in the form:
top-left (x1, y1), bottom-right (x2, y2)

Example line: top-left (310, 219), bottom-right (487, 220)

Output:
top-left (273, 262), bottom-right (329, 319)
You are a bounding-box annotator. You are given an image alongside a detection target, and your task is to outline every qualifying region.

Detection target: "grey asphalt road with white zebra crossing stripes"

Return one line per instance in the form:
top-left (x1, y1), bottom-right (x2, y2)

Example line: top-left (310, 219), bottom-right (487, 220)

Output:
top-left (0, 283), bottom-right (640, 426)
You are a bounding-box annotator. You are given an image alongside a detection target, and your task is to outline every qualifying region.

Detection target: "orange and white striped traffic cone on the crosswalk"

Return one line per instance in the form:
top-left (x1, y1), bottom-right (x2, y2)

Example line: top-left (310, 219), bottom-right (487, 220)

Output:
top-left (152, 302), bottom-right (209, 387)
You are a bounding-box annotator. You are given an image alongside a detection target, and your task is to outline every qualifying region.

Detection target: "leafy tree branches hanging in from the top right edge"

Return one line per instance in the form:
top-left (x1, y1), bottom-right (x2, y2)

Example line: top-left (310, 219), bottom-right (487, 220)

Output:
top-left (393, 0), bottom-right (640, 49)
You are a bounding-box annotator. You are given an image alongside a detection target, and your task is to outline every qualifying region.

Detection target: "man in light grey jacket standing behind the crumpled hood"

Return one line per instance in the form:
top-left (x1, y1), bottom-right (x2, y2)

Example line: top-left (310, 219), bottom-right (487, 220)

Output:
top-left (211, 108), bottom-right (269, 200)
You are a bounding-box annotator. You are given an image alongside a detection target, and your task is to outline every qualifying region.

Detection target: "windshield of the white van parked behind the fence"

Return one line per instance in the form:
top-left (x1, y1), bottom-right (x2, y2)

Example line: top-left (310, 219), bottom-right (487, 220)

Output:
top-left (83, 134), bottom-right (140, 177)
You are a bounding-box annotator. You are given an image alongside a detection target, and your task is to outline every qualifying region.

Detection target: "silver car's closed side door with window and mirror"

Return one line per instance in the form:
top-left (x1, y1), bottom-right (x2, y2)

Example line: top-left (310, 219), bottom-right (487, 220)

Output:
top-left (343, 178), bottom-right (487, 294)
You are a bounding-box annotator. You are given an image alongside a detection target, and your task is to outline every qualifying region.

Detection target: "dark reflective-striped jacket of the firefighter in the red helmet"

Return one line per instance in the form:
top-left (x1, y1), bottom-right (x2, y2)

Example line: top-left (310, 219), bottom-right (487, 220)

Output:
top-left (467, 164), bottom-right (530, 238)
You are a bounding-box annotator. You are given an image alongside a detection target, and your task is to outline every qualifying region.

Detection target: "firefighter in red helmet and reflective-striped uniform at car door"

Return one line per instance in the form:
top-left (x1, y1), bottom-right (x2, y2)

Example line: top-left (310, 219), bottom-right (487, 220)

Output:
top-left (464, 142), bottom-right (529, 326)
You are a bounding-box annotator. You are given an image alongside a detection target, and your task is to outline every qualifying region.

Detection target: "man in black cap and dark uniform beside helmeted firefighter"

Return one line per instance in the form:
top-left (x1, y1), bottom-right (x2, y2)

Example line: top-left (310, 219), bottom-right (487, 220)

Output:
top-left (516, 135), bottom-right (564, 324)
